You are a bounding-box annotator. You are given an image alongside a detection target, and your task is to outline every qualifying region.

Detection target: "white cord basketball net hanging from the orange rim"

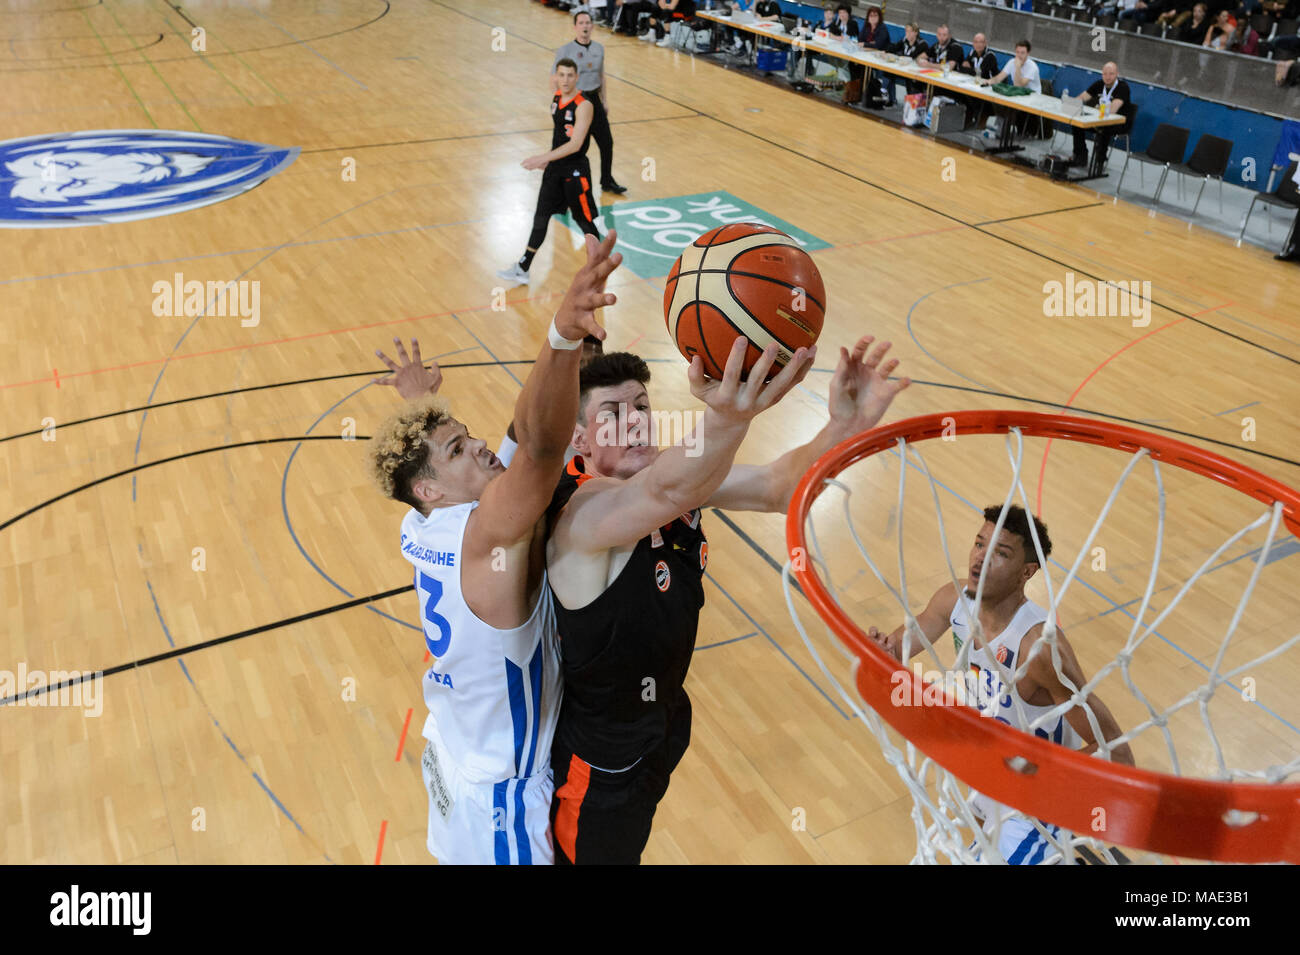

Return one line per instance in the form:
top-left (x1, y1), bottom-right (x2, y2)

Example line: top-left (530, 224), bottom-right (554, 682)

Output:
top-left (783, 427), bottom-right (1300, 864)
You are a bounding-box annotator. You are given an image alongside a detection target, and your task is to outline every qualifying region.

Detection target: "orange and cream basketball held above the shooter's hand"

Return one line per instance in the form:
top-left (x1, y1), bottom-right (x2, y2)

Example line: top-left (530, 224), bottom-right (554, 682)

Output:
top-left (663, 222), bottom-right (826, 378)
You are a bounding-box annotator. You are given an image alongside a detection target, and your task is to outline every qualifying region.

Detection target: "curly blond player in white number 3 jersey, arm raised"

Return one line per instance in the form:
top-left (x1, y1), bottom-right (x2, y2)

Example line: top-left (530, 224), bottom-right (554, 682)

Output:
top-left (369, 231), bottom-right (621, 864)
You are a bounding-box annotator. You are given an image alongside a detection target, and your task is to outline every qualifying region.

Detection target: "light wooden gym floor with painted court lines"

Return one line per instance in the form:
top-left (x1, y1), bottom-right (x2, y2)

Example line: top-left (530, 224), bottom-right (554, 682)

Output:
top-left (0, 0), bottom-right (1300, 864)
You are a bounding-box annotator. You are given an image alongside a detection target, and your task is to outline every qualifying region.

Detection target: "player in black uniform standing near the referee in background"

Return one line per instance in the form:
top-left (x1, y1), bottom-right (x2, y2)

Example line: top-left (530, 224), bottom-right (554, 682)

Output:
top-left (497, 60), bottom-right (601, 285)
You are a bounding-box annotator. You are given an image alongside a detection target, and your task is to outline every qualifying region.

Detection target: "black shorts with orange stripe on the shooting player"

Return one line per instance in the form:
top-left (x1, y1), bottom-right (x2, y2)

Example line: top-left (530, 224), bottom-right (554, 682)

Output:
top-left (551, 693), bottom-right (690, 865)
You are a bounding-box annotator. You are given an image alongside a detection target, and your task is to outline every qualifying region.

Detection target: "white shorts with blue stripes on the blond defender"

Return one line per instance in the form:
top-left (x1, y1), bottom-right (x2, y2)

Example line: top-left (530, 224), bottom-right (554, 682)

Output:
top-left (420, 741), bottom-right (555, 865)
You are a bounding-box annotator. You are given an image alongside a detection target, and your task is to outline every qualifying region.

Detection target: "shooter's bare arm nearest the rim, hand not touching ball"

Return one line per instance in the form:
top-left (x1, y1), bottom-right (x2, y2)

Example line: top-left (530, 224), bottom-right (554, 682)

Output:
top-left (709, 335), bottom-right (911, 513)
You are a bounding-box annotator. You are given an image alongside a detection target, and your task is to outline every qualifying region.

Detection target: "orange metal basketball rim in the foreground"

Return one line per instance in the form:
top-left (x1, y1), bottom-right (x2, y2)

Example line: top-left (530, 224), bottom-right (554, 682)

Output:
top-left (785, 411), bottom-right (1300, 863)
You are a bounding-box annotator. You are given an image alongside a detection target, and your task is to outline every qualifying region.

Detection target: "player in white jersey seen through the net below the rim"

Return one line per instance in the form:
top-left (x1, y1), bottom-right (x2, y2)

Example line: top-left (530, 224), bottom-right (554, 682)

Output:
top-left (868, 504), bottom-right (1134, 865)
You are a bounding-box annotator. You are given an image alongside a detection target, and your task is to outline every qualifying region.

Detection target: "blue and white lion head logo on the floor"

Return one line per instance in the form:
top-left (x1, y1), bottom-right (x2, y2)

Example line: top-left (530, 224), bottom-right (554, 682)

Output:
top-left (0, 130), bottom-right (298, 229)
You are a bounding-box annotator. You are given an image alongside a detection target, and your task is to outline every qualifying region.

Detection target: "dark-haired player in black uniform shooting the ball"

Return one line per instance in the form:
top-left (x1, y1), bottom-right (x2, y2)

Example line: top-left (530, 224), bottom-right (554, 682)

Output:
top-left (546, 337), bottom-right (907, 864)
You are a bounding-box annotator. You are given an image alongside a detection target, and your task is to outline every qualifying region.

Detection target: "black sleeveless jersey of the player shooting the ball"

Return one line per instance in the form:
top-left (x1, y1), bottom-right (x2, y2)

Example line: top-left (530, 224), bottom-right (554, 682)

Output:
top-left (547, 457), bottom-right (709, 769)
